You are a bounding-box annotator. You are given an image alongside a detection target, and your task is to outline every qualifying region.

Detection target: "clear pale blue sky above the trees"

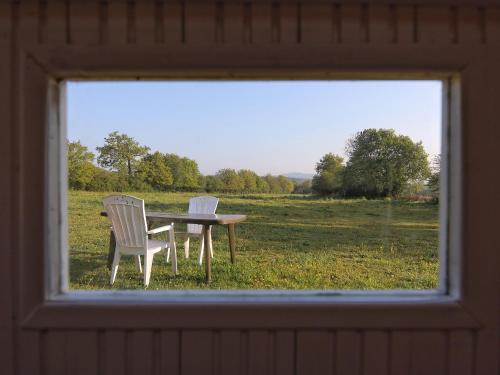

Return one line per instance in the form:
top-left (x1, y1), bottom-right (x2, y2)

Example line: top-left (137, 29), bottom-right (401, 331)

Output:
top-left (67, 81), bottom-right (442, 175)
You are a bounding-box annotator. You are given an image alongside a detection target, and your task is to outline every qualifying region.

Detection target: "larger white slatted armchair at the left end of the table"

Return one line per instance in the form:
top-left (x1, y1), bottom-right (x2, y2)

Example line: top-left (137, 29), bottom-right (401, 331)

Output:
top-left (102, 195), bottom-right (177, 287)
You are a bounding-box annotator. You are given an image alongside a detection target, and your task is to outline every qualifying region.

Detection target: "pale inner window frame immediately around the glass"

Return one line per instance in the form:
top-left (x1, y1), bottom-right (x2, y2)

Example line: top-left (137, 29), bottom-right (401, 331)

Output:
top-left (45, 71), bottom-right (462, 304)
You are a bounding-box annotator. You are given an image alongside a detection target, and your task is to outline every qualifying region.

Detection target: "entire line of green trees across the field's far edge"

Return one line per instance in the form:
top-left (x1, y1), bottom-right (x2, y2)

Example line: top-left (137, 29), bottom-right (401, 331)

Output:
top-left (68, 129), bottom-right (440, 198)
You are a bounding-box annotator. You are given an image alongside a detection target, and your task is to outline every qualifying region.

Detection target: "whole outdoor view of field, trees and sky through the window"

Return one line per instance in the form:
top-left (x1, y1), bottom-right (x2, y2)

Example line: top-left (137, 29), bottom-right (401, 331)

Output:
top-left (67, 80), bottom-right (443, 290)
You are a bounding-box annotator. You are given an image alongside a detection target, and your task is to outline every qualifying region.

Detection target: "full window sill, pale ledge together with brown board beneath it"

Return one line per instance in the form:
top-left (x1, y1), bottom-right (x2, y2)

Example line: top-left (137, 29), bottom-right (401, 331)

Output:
top-left (22, 292), bottom-right (479, 329)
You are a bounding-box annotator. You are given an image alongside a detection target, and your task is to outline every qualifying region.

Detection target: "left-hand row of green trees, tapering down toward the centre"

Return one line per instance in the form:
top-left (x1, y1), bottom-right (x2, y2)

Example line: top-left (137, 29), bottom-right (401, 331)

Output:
top-left (68, 132), bottom-right (295, 194)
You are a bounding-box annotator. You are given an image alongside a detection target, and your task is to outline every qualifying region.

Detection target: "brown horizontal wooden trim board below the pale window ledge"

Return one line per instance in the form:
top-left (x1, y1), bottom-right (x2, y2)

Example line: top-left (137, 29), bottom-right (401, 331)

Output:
top-left (23, 302), bottom-right (478, 329)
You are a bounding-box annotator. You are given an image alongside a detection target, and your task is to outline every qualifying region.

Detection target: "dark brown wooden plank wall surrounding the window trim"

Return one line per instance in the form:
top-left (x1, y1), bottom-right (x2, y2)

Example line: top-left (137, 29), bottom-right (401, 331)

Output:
top-left (0, 0), bottom-right (500, 375)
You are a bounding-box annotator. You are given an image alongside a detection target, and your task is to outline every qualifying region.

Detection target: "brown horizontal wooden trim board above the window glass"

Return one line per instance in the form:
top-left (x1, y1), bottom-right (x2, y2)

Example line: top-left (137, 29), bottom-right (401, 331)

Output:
top-left (24, 44), bottom-right (479, 80)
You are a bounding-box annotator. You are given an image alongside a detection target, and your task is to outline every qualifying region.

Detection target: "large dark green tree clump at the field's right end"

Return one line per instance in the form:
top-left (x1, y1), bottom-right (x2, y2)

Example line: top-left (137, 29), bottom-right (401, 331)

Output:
top-left (312, 129), bottom-right (440, 198)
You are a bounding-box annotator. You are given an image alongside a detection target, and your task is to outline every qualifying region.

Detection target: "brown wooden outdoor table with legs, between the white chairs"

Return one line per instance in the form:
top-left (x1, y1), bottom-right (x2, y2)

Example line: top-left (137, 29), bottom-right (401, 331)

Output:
top-left (101, 211), bottom-right (247, 282)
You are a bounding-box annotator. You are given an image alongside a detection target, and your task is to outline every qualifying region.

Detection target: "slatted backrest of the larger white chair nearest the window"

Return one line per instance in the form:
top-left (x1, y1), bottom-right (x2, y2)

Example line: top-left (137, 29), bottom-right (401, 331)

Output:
top-left (102, 195), bottom-right (147, 248)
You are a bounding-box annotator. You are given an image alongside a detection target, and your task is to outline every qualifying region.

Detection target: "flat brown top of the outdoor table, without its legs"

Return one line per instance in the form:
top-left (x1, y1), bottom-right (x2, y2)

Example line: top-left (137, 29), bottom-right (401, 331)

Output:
top-left (101, 211), bottom-right (247, 225)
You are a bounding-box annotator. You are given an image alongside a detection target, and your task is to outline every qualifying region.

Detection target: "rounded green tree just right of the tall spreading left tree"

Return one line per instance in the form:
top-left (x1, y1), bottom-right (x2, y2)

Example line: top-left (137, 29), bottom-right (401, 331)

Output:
top-left (137, 151), bottom-right (174, 191)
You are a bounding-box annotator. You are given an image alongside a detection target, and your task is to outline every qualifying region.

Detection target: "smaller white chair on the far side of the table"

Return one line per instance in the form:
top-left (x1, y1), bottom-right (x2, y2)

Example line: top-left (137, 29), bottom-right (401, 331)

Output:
top-left (179, 196), bottom-right (219, 266)
